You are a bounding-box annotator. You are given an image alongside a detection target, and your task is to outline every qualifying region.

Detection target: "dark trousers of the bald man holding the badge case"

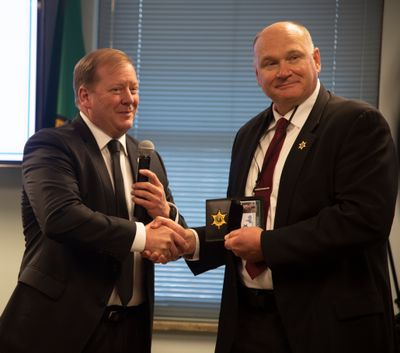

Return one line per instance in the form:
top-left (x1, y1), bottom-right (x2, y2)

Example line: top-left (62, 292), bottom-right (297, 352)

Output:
top-left (230, 286), bottom-right (291, 353)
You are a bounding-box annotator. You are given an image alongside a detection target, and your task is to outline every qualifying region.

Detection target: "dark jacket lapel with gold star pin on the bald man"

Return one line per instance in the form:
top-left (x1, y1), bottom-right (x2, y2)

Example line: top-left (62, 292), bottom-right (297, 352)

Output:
top-left (274, 85), bottom-right (329, 228)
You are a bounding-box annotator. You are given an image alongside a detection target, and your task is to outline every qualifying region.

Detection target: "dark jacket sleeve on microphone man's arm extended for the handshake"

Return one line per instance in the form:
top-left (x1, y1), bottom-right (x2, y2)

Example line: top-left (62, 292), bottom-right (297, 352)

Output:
top-left (22, 129), bottom-right (136, 260)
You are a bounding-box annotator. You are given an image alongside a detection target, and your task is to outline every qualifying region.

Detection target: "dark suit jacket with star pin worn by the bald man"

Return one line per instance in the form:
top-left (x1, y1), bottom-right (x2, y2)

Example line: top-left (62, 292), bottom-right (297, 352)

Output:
top-left (188, 87), bottom-right (398, 353)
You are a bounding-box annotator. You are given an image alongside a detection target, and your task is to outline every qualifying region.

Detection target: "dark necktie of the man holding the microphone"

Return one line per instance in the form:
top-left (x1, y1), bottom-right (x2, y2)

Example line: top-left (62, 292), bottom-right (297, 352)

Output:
top-left (107, 139), bottom-right (133, 306)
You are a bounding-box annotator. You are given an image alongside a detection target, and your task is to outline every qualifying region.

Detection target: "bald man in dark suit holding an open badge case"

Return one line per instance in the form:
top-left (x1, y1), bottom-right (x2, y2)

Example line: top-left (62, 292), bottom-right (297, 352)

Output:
top-left (162, 22), bottom-right (398, 353)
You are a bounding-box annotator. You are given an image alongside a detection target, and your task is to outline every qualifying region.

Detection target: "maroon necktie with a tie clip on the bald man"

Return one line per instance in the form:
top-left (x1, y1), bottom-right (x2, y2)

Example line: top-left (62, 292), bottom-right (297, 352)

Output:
top-left (246, 118), bottom-right (289, 279)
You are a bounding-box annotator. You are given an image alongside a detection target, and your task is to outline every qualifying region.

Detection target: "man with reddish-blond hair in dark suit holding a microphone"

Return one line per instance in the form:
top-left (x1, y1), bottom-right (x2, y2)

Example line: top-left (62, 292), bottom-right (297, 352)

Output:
top-left (0, 49), bottom-right (186, 353)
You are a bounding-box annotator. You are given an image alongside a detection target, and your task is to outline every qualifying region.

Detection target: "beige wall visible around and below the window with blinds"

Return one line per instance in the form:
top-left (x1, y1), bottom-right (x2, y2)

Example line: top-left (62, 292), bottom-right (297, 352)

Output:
top-left (0, 0), bottom-right (400, 353)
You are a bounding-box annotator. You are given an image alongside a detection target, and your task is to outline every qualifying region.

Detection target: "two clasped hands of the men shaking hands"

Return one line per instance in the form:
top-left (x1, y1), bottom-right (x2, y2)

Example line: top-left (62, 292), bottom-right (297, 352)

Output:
top-left (142, 216), bottom-right (196, 264)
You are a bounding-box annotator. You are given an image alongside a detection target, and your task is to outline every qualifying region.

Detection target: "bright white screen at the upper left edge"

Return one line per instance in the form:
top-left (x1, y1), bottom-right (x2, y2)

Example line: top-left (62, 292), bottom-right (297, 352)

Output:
top-left (0, 0), bottom-right (37, 162)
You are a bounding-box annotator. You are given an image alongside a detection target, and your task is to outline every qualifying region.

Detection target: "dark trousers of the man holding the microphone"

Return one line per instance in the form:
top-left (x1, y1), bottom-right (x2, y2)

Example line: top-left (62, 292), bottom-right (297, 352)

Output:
top-left (82, 304), bottom-right (151, 353)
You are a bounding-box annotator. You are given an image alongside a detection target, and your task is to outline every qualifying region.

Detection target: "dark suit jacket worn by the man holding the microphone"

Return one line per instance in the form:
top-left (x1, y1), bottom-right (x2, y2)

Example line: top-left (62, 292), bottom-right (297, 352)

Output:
top-left (0, 116), bottom-right (184, 353)
